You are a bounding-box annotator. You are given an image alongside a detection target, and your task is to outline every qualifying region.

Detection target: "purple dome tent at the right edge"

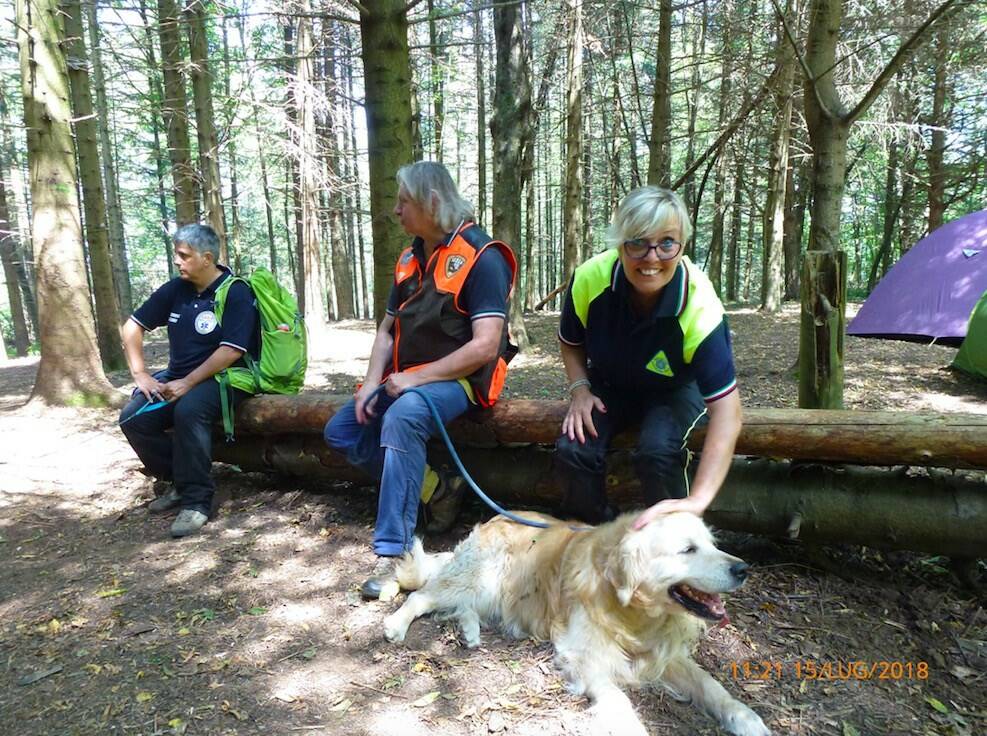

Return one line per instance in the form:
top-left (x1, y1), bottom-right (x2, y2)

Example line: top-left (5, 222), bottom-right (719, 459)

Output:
top-left (847, 210), bottom-right (987, 345)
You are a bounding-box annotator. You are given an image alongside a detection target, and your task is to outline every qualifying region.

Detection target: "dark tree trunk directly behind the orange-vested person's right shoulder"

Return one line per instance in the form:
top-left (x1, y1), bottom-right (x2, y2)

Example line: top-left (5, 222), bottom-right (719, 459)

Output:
top-left (490, 3), bottom-right (533, 350)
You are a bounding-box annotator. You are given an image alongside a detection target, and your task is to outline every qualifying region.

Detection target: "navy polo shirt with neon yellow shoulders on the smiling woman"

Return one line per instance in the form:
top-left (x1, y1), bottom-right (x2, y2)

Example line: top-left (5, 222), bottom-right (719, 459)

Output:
top-left (559, 250), bottom-right (737, 402)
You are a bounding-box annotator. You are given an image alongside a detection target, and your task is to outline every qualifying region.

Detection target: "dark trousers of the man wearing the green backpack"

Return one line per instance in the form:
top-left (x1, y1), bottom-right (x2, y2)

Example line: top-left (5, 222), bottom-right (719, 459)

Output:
top-left (120, 376), bottom-right (250, 515)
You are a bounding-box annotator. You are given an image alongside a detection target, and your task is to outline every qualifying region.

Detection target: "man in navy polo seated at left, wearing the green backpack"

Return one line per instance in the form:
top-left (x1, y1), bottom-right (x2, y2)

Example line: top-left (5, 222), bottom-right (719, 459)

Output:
top-left (120, 225), bottom-right (258, 537)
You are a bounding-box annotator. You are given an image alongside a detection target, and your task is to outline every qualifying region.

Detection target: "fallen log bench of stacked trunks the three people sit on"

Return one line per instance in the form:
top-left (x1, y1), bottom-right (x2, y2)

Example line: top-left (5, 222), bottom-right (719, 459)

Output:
top-left (214, 392), bottom-right (987, 557)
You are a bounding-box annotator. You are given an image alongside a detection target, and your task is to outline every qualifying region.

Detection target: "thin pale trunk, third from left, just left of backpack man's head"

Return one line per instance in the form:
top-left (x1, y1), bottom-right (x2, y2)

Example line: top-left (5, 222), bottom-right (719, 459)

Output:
top-left (84, 2), bottom-right (131, 320)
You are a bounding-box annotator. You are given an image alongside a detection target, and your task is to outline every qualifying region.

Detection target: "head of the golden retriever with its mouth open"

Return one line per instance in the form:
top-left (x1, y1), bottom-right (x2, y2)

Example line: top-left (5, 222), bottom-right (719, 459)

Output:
top-left (604, 513), bottom-right (747, 621)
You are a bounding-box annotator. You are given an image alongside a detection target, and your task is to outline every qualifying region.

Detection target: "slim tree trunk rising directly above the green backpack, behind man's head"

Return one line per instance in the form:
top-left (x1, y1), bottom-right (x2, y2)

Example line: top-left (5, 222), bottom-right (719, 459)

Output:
top-left (185, 0), bottom-right (231, 264)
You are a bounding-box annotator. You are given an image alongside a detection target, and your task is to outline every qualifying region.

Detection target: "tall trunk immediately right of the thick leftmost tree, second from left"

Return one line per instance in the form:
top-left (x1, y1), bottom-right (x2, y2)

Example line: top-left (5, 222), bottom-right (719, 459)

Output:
top-left (59, 0), bottom-right (127, 371)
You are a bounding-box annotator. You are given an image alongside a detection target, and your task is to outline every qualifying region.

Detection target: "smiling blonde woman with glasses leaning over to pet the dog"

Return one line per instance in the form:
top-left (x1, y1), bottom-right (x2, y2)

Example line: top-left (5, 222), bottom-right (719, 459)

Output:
top-left (556, 186), bottom-right (741, 528)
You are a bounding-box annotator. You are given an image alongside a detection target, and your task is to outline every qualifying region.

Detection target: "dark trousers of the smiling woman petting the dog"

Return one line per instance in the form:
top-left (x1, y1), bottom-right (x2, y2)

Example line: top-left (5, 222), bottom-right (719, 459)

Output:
top-left (555, 383), bottom-right (706, 524)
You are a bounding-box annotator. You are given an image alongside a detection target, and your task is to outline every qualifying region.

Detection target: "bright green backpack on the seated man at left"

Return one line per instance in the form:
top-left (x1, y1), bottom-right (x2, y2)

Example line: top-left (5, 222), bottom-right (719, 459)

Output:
top-left (215, 268), bottom-right (308, 441)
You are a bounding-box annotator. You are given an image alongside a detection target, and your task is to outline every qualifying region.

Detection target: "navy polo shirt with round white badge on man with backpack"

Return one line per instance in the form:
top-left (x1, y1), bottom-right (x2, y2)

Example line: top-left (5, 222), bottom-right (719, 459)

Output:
top-left (130, 266), bottom-right (258, 380)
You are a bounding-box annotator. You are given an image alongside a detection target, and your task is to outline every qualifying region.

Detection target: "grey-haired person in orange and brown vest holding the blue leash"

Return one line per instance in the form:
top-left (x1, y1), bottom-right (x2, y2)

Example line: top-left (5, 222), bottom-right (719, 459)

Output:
top-left (325, 161), bottom-right (517, 598)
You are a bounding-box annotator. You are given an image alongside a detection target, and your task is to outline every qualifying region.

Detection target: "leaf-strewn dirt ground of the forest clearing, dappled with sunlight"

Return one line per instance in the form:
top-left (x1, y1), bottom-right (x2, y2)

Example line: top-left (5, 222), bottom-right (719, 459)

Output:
top-left (0, 307), bottom-right (987, 736)
